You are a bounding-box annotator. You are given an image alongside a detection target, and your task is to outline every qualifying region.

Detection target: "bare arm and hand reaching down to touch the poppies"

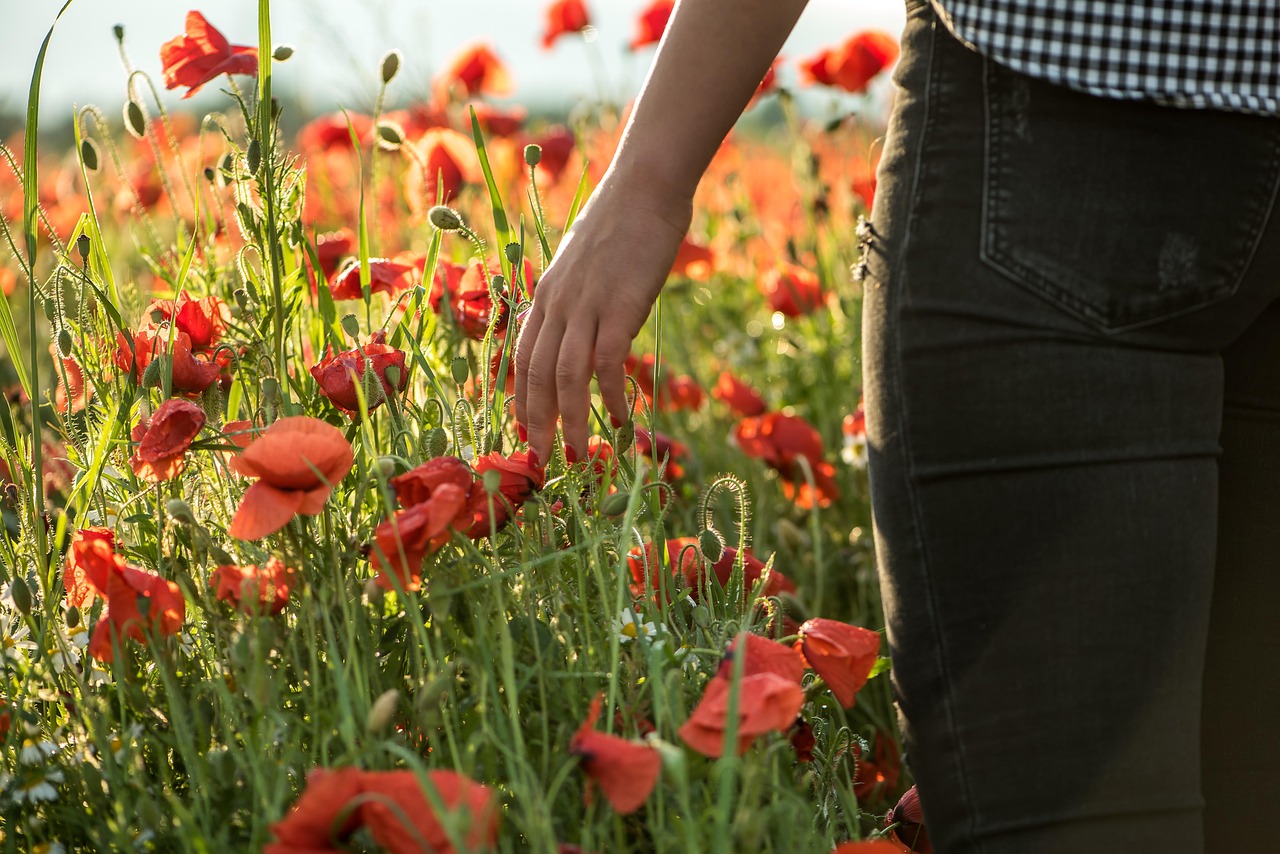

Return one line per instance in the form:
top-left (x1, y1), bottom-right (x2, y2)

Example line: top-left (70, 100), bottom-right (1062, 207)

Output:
top-left (516, 0), bottom-right (806, 462)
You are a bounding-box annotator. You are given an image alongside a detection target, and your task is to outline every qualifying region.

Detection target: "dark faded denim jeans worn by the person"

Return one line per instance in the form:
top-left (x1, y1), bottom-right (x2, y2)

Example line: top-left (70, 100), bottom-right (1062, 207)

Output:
top-left (864, 3), bottom-right (1280, 854)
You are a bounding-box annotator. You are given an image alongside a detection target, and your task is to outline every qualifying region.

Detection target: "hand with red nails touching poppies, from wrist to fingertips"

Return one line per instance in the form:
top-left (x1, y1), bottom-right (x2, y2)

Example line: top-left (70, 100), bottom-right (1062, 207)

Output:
top-left (516, 177), bottom-right (691, 465)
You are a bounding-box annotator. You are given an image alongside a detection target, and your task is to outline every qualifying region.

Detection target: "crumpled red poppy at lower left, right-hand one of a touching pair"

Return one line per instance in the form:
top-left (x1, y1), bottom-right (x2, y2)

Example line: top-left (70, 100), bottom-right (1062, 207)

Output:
top-left (88, 558), bottom-right (187, 661)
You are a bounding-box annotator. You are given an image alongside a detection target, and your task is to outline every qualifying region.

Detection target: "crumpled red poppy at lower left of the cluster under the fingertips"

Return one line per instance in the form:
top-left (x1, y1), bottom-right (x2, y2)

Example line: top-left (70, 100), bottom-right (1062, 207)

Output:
top-left (372, 484), bottom-right (468, 590)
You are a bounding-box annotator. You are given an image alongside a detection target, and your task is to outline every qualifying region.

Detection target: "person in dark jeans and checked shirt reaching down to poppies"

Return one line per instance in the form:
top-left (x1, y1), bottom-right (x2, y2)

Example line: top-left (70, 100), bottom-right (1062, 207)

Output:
top-left (516, 0), bottom-right (1280, 854)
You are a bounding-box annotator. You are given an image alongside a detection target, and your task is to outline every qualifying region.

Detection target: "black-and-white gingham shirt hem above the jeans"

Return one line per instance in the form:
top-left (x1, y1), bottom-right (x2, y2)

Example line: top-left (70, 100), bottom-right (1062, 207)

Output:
top-left (933, 0), bottom-right (1280, 115)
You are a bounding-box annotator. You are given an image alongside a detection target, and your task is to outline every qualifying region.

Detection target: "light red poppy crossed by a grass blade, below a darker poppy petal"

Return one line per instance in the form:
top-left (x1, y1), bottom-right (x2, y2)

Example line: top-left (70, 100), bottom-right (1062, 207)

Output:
top-left (680, 672), bottom-right (804, 758)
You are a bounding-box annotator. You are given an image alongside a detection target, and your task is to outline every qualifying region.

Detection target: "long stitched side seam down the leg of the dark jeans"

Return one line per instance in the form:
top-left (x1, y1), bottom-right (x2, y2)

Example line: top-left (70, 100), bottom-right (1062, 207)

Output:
top-left (890, 11), bottom-right (986, 854)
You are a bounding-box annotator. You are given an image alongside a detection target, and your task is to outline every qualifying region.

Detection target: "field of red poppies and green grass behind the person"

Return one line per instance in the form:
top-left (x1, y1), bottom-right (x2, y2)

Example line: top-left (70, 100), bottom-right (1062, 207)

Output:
top-left (0, 0), bottom-right (927, 853)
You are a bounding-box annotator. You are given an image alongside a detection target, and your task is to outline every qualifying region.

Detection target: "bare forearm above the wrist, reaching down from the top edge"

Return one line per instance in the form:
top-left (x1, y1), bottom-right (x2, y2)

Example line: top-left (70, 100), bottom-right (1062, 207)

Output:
top-left (607, 0), bottom-right (808, 217)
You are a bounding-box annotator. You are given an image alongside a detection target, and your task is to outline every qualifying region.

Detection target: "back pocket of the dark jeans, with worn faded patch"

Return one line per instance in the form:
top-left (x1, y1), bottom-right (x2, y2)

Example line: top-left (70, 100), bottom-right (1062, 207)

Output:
top-left (980, 60), bottom-right (1280, 332)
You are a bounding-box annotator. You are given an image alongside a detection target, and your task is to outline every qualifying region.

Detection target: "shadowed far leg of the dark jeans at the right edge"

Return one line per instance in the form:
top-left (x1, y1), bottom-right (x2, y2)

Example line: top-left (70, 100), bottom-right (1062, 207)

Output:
top-left (1201, 299), bottom-right (1280, 854)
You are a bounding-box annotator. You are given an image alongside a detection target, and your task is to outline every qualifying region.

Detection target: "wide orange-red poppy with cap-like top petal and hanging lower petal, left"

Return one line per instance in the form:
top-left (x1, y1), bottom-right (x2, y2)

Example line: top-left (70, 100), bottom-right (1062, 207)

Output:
top-left (227, 415), bottom-right (355, 540)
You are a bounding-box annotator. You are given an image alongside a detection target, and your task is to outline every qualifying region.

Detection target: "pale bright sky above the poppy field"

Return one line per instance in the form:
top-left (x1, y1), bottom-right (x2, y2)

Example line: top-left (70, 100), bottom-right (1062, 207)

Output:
top-left (0, 0), bottom-right (904, 122)
